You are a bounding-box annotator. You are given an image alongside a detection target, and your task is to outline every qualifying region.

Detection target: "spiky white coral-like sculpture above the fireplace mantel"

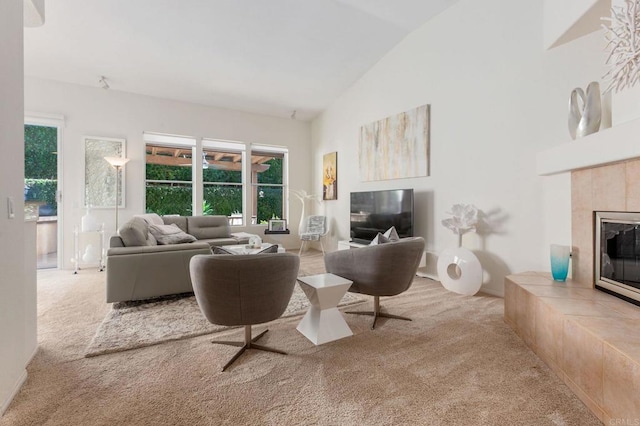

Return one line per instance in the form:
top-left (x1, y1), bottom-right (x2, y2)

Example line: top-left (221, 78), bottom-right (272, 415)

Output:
top-left (602, 0), bottom-right (640, 93)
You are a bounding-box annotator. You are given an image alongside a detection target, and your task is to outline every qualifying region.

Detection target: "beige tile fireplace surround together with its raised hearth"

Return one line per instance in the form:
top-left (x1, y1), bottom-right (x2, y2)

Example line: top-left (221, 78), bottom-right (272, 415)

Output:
top-left (504, 159), bottom-right (640, 425)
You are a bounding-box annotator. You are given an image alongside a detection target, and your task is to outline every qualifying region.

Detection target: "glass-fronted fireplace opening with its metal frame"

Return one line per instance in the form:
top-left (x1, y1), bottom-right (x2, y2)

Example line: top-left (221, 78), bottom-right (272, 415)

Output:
top-left (594, 212), bottom-right (640, 305)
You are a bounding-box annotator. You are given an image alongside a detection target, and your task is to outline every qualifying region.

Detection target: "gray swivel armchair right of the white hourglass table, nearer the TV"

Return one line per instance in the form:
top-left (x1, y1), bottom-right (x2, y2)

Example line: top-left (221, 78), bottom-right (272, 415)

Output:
top-left (324, 237), bottom-right (424, 330)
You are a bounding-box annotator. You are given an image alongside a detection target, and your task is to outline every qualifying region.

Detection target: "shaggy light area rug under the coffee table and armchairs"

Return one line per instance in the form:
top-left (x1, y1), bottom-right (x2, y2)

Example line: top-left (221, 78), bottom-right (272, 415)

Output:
top-left (84, 285), bottom-right (364, 358)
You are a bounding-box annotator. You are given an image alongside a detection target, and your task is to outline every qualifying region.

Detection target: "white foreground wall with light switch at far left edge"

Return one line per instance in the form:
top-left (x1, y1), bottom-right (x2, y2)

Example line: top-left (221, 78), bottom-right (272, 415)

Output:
top-left (0, 0), bottom-right (36, 415)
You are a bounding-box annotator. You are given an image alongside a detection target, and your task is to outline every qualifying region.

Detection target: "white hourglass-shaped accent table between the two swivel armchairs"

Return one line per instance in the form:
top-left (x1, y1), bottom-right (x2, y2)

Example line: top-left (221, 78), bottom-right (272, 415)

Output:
top-left (297, 274), bottom-right (353, 345)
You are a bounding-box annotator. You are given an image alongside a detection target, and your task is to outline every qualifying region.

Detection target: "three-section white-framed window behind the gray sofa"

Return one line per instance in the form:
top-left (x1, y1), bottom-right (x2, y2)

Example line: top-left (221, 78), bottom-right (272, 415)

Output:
top-left (144, 133), bottom-right (288, 225)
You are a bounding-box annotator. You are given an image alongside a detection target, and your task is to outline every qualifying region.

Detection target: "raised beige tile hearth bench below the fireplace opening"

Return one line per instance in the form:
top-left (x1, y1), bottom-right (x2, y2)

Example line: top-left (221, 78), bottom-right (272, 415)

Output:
top-left (504, 272), bottom-right (640, 424)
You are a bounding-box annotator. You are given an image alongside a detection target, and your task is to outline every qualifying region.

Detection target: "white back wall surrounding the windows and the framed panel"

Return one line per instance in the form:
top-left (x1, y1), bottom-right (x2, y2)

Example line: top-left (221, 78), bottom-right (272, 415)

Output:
top-left (25, 78), bottom-right (311, 268)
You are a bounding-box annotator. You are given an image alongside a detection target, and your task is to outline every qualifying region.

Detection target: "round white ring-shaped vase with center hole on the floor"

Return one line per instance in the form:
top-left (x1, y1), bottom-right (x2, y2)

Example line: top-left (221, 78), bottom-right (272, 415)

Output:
top-left (438, 247), bottom-right (482, 296)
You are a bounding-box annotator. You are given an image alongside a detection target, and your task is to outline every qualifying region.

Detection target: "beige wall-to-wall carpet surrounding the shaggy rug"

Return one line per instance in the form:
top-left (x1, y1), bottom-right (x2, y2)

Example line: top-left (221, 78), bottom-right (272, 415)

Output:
top-left (0, 251), bottom-right (600, 426)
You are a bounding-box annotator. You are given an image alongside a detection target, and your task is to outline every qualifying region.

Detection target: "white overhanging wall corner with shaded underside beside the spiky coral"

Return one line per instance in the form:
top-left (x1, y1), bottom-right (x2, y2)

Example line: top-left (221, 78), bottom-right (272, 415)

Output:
top-left (543, 0), bottom-right (611, 50)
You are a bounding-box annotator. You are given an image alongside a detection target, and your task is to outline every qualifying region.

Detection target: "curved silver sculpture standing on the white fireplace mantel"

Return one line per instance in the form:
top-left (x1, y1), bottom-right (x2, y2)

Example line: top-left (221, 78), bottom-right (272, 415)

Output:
top-left (568, 81), bottom-right (602, 139)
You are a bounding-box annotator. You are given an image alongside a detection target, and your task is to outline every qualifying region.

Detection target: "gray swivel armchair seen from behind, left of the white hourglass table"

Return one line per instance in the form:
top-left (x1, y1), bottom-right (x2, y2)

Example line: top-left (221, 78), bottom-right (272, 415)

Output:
top-left (189, 253), bottom-right (300, 371)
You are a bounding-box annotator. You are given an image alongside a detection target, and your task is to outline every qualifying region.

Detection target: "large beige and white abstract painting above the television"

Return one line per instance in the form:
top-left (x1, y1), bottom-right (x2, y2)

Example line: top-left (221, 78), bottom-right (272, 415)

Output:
top-left (359, 105), bottom-right (430, 182)
